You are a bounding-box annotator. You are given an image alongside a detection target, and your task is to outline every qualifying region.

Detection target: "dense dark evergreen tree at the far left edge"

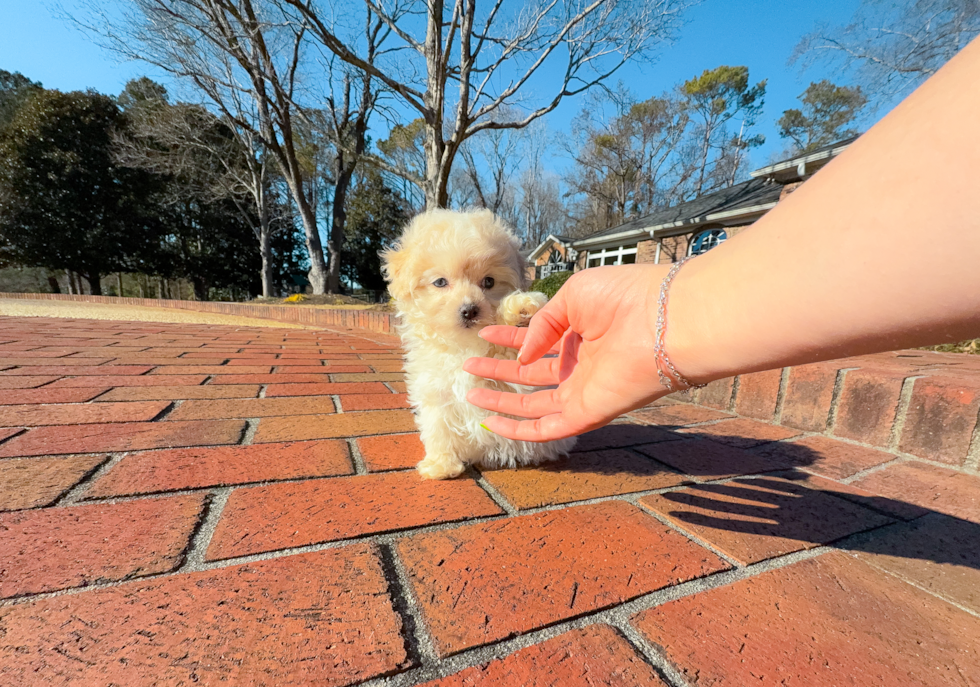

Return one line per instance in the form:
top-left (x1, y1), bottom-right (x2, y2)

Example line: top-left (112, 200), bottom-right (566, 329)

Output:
top-left (0, 90), bottom-right (160, 294)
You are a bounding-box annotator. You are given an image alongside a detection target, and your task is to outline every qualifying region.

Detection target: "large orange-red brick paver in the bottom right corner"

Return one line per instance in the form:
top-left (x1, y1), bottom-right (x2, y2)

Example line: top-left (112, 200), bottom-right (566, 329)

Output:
top-left (634, 553), bottom-right (980, 687)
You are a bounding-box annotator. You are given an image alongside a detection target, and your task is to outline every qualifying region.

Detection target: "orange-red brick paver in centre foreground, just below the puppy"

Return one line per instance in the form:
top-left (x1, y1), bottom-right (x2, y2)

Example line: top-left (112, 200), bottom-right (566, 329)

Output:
top-left (398, 502), bottom-right (727, 656)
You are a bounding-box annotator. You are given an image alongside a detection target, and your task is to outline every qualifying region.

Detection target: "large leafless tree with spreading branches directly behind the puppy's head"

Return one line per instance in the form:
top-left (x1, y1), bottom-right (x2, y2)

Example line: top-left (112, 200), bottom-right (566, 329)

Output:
top-left (276, 0), bottom-right (690, 207)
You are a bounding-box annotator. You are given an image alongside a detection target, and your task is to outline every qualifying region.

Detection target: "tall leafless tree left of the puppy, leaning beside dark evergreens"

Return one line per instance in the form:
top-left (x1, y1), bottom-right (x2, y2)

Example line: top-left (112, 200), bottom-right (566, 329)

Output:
top-left (69, 0), bottom-right (344, 293)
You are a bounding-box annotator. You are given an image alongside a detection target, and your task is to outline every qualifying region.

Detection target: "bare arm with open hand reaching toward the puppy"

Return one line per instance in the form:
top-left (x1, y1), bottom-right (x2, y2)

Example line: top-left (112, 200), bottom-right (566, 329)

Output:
top-left (466, 39), bottom-right (980, 441)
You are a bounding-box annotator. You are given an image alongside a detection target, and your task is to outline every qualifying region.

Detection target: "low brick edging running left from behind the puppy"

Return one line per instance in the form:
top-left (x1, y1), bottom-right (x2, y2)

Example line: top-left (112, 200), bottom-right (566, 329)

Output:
top-left (0, 293), bottom-right (396, 334)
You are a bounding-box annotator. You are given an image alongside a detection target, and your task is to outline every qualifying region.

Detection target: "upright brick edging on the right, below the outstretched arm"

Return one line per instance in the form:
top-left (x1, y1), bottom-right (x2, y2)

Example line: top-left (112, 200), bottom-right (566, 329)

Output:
top-left (674, 351), bottom-right (980, 472)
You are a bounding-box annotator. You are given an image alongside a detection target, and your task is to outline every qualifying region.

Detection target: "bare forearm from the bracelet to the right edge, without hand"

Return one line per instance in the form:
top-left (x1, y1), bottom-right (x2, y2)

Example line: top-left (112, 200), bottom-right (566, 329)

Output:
top-left (667, 36), bottom-right (980, 388)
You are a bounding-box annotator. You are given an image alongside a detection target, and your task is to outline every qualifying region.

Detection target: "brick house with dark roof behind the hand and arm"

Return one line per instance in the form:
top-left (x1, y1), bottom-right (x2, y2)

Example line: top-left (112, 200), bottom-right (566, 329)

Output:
top-left (528, 137), bottom-right (856, 279)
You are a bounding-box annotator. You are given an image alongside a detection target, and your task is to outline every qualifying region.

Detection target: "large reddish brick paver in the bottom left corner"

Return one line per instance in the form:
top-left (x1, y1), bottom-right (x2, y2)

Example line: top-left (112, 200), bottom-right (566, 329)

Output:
top-left (0, 544), bottom-right (411, 686)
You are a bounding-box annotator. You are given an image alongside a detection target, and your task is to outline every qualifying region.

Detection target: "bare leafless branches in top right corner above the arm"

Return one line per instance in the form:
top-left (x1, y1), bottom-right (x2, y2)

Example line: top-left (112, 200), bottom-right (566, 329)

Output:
top-left (793, 0), bottom-right (980, 105)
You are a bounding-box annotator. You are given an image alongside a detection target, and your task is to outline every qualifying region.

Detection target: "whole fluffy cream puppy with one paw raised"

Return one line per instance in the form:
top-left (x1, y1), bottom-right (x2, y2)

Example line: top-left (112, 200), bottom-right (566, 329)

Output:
top-left (381, 210), bottom-right (574, 479)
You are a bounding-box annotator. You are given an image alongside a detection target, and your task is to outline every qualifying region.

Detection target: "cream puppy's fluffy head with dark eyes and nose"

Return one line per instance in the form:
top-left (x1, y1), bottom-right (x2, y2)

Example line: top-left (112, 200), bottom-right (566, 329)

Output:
top-left (382, 210), bottom-right (525, 343)
